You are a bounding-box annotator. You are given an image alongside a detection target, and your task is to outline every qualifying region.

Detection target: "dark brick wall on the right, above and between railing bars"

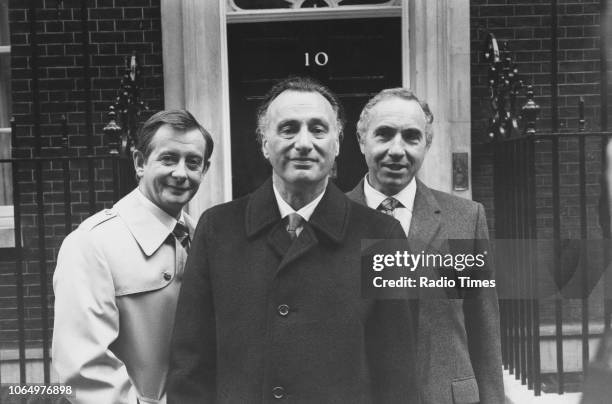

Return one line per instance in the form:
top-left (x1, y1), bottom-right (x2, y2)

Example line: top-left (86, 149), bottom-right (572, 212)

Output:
top-left (470, 0), bottom-right (612, 237)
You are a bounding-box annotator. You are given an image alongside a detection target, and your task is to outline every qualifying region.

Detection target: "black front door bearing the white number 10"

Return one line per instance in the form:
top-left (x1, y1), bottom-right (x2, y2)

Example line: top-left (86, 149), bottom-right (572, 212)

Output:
top-left (228, 17), bottom-right (402, 198)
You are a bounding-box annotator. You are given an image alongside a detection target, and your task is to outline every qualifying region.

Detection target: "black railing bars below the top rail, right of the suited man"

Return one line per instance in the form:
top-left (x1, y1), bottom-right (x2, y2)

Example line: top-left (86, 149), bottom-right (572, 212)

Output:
top-left (493, 132), bottom-right (612, 395)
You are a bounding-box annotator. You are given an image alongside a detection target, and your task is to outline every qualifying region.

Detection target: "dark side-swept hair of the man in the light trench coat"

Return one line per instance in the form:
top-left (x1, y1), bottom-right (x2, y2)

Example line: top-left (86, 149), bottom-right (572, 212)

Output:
top-left (136, 109), bottom-right (214, 162)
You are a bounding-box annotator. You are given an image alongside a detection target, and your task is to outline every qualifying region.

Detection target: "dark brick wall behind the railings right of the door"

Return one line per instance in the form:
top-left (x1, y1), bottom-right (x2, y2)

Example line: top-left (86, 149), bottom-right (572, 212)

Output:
top-left (470, 0), bottom-right (612, 322)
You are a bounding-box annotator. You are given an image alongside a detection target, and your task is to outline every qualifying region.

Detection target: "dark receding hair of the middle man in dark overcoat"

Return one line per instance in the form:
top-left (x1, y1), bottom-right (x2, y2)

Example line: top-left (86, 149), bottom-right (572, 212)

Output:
top-left (257, 77), bottom-right (344, 144)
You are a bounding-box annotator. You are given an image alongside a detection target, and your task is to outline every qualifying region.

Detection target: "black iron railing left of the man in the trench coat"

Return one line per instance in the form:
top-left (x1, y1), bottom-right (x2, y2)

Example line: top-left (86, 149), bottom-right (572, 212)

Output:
top-left (0, 114), bottom-right (131, 384)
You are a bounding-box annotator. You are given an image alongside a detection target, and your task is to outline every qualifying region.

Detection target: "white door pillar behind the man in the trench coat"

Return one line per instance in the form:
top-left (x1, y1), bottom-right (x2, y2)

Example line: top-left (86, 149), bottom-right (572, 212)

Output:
top-left (161, 0), bottom-right (232, 218)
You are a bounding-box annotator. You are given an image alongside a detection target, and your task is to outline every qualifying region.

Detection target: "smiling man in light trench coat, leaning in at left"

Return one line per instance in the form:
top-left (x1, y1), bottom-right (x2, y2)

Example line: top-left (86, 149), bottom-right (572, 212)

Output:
top-left (53, 110), bottom-right (213, 404)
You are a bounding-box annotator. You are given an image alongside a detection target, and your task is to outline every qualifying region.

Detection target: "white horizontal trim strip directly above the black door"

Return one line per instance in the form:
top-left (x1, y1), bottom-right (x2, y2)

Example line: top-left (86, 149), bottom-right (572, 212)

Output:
top-left (227, 5), bottom-right (406, 24)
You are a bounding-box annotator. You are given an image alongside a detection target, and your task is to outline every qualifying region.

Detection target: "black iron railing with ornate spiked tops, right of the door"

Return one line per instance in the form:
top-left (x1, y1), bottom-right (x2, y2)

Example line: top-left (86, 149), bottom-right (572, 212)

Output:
top-left (483, 11), bottom-right (612, 395)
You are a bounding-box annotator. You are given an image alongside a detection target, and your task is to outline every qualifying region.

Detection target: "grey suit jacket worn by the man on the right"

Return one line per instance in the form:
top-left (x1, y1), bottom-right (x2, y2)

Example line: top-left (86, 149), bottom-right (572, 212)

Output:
top-left (347, 180), bottom-right (504, 404)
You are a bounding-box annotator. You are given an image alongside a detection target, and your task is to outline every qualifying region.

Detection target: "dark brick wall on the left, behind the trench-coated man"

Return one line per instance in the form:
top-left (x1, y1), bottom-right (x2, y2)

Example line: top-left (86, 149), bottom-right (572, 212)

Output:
top-left (0, 0), bottom-right (163, 346)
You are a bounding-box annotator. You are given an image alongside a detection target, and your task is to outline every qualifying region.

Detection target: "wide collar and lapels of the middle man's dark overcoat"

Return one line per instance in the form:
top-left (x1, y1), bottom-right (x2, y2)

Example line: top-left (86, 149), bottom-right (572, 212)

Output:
top-left (246, 179), bottom-right (350, 271)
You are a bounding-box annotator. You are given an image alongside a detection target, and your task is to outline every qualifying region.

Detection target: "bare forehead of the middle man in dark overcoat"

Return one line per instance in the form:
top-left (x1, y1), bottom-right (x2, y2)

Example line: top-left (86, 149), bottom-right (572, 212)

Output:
top-left (267, 90), bottom-right (336, 120)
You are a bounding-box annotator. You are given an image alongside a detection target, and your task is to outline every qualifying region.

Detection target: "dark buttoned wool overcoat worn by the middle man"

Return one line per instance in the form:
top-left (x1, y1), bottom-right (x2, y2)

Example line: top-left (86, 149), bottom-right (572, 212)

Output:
top-left (168, 180), bottom-right (417, 404)
